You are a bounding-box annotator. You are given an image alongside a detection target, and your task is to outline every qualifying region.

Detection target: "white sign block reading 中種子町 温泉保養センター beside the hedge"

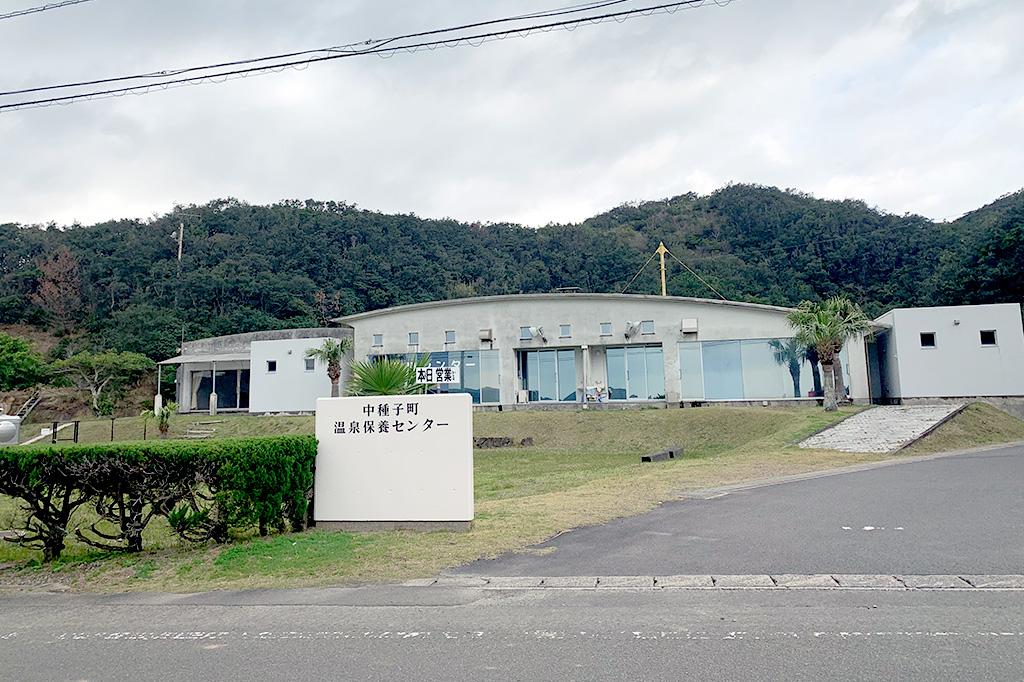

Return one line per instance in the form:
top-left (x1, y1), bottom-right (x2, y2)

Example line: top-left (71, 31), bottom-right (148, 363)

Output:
top-left (313, 393), bottom-right (473, 521)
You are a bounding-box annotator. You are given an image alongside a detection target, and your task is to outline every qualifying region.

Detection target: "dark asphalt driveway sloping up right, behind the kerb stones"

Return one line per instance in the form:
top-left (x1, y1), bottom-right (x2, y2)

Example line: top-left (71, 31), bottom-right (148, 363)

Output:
top-left (459, 446), bottom-right (1024, 576)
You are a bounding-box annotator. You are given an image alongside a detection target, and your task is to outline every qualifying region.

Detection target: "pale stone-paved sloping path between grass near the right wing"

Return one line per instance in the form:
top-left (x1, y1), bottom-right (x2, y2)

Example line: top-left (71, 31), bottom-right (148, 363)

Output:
top-left (800, 404), bottom-right (964, 453)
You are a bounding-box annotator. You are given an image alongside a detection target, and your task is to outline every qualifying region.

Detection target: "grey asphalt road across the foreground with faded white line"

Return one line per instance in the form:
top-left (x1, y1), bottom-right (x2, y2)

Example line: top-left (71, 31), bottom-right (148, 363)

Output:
top-left (0, 588), bottom-right (1024, 682)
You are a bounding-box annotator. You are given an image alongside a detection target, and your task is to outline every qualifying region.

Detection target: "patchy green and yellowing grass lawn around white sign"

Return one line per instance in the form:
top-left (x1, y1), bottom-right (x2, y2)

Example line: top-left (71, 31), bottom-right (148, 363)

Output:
top-left (0, 406), bottom-right (1024, 591)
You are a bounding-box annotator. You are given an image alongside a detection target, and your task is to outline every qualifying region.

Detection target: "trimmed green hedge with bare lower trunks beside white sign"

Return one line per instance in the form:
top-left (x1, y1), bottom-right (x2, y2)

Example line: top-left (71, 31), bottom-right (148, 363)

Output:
top-left (0, 436), bottom-right (316, 561)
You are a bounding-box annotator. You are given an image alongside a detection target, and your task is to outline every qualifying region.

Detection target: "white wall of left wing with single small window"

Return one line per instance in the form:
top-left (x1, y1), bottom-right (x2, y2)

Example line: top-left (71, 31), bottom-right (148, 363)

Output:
top-left (249, 338), bottom-right (337, 413)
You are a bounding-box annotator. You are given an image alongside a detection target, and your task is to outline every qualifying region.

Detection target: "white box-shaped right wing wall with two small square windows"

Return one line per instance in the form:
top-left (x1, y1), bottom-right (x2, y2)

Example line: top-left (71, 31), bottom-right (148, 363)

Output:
top-left (887, 303), bottom-right (1024, 398)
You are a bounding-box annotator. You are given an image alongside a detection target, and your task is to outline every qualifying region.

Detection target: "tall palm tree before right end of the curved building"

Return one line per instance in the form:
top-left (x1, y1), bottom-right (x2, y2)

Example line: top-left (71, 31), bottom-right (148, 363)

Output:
top-left (786, 296), bottom-right (870, 412)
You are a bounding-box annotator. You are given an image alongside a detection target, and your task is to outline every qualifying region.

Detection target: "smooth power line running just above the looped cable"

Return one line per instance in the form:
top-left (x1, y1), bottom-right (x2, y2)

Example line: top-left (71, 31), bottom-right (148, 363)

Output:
top-left (0, 0), bottom-right (631, 97)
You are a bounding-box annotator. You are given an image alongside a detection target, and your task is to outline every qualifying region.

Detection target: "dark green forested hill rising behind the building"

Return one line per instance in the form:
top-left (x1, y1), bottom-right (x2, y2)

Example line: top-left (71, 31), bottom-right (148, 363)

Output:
top-left (0, 185), bottom-right (1024, 358)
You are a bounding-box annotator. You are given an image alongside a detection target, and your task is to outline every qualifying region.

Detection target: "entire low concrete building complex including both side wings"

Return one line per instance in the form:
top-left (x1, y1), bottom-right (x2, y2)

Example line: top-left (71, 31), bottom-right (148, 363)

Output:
top-left (163, 293), bottom-right (1024, 413)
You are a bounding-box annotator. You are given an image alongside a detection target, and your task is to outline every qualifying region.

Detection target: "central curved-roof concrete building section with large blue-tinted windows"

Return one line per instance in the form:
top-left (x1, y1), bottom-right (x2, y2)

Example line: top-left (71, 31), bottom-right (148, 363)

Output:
top-left (335, 293), bottom-right (868, 406)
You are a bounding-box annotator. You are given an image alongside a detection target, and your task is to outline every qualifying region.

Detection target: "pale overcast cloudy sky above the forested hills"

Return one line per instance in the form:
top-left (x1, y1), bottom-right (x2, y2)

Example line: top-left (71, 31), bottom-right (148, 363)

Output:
top-left (0, 0), bottom-right (1024, 225)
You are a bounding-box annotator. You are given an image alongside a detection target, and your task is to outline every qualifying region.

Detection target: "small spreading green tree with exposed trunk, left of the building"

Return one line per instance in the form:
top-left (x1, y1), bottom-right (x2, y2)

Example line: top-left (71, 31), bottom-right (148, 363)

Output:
top-left (53, 350), bottom-right (157, 415)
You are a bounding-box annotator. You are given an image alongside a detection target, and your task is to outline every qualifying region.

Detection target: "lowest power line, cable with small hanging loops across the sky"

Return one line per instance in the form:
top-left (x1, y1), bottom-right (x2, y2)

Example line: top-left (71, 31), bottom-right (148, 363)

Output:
top-left (0, 0), bottom-right (732, 112)
